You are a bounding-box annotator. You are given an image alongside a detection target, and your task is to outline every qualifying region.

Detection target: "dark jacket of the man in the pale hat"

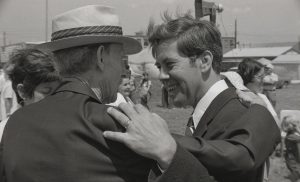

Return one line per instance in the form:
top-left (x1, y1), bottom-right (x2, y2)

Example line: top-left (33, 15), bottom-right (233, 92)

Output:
top-left (0, 79), bottom-right (152, 182)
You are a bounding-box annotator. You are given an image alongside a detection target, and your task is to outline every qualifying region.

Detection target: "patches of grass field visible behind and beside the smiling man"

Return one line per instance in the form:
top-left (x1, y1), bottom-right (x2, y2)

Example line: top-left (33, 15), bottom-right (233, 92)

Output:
top-left (149, 80), bottom-right (300, 182)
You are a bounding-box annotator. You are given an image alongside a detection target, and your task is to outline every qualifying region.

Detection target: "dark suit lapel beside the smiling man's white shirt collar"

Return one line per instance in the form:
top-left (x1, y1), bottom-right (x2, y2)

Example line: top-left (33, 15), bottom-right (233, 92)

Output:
top-left (193, 87), bottom-right (237, 136)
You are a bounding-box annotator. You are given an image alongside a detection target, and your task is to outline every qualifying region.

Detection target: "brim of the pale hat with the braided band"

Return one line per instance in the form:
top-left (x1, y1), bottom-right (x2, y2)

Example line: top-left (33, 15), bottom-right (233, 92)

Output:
top-left (35, 35), bottom-right (142, 55)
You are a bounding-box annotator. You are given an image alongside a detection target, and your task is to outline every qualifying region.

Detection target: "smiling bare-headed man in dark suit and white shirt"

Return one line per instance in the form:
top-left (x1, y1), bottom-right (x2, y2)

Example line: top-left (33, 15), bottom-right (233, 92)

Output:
top-left (104, 14), bottom-right (280, 182)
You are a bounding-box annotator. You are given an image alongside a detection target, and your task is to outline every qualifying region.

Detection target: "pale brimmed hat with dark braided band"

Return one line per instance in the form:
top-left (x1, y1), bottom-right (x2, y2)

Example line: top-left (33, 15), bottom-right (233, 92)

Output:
top-left (36, 5), bottom-right (142, 54)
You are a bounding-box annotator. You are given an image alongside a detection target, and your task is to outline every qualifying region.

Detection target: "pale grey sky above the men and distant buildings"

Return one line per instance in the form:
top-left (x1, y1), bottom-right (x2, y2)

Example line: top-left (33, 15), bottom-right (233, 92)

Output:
top-left (0, 0), bottom-right (300, 45)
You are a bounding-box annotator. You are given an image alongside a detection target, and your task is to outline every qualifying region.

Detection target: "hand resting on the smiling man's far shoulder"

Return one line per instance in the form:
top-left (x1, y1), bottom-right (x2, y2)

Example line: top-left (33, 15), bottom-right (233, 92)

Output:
top-left (236, 89), bottom-right (267, 107)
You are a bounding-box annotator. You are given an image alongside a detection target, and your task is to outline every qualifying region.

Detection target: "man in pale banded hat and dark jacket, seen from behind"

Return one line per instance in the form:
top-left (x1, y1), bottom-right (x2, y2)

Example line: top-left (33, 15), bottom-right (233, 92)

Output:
top-left (0, 5), bottom-right (152, 182)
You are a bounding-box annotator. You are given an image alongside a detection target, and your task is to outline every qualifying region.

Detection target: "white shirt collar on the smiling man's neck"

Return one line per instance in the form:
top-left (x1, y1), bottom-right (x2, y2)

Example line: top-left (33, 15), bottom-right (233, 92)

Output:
top-left (192, 80), bottom-right (228, 128)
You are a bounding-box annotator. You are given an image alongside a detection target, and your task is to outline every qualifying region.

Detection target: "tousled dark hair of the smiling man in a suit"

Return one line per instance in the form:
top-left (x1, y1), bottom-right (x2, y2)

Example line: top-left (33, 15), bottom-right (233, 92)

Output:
top-left (148, 12), bottom-right (223, 73)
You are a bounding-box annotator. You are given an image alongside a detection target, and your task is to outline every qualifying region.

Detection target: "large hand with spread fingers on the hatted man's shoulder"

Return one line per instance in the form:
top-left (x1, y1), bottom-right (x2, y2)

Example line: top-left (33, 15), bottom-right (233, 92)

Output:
top-left (103, 103), bottom-right (177, 169)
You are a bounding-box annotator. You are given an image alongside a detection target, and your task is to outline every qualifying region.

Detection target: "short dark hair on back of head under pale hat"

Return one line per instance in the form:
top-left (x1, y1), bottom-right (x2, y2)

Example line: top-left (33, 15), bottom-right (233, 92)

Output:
top-left (54, 44), bottom-right (107, 76)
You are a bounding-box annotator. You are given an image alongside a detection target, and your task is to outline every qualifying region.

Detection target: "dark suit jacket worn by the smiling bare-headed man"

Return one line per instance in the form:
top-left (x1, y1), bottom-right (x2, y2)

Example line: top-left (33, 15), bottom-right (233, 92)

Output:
top-left (160, 88), bottom-right (280, 182)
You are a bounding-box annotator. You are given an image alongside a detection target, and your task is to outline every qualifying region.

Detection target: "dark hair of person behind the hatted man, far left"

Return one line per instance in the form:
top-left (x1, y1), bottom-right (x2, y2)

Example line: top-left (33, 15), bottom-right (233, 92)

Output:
top-left (4, 49), bottom-right (60, 104)
